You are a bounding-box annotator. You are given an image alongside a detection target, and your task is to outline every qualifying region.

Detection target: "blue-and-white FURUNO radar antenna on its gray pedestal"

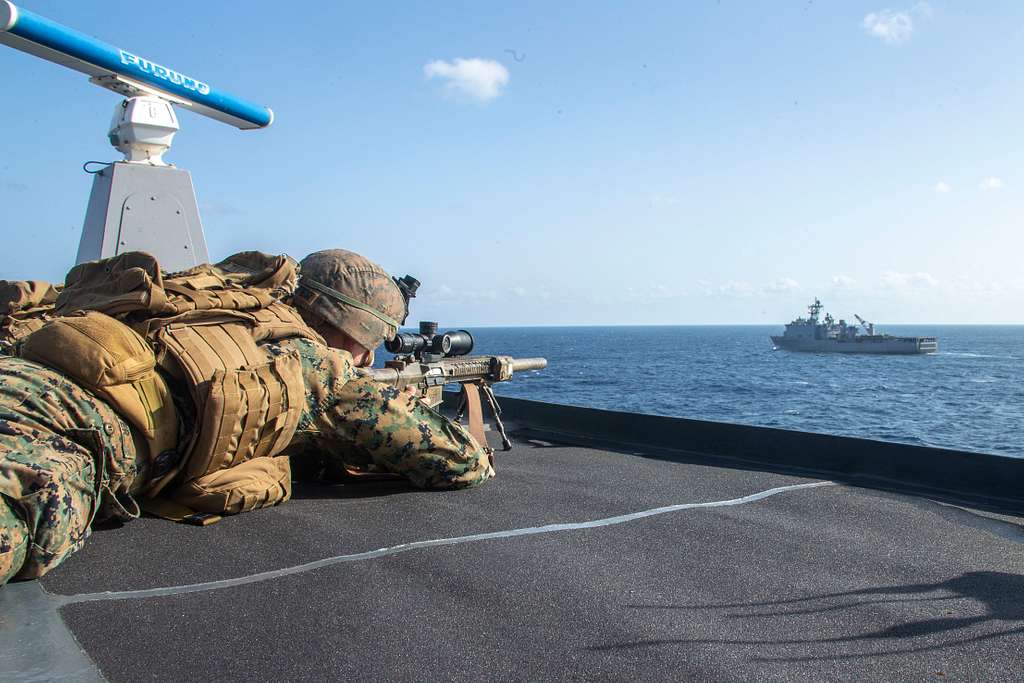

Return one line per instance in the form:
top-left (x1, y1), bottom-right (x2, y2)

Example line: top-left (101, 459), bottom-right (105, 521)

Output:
top-left (0, 0), bottom-right (273, 270)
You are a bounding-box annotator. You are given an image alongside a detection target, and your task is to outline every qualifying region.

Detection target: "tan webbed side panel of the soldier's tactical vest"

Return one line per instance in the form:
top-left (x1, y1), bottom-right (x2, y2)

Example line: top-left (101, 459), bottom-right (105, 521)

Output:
top-left (158, 322), bottom-right (304, 480)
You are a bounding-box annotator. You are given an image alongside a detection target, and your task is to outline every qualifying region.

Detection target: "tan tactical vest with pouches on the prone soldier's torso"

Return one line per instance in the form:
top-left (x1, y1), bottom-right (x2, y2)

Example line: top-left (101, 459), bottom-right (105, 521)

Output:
top-left (20, 252), bottom-right (324, 518)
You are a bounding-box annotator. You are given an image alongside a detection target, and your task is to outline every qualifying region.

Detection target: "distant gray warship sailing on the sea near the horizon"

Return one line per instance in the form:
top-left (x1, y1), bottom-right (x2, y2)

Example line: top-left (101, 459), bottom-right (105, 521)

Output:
top-left (771, 298), bottom-right (939, 355)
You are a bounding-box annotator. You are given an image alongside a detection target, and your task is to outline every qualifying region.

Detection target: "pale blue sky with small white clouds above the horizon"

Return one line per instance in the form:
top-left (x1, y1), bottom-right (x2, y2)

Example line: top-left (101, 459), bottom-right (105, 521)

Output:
top-left (0, 0), bottom-right (1024, 326)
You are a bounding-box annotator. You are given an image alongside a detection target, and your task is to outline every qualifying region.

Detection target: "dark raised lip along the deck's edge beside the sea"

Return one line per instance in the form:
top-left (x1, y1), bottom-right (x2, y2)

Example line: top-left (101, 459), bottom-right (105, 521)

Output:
top-left (456, 396), bottom-right (1024, 515)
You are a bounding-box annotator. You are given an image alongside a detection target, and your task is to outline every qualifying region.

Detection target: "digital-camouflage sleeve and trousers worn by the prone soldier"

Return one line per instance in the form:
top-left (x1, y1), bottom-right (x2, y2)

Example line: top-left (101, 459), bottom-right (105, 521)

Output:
top-left (0, 339), bottom-right (494, 585)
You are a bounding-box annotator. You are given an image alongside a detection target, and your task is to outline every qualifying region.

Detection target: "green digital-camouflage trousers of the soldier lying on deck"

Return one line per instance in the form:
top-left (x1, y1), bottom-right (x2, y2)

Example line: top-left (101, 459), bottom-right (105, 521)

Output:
top-left (0, 356), bottom-right (140, 585)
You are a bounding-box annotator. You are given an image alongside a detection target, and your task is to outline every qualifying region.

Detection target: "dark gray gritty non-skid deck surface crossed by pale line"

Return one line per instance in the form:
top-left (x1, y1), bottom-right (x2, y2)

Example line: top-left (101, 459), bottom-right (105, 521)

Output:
top-left (36, 443), bottom-right (1024, 680)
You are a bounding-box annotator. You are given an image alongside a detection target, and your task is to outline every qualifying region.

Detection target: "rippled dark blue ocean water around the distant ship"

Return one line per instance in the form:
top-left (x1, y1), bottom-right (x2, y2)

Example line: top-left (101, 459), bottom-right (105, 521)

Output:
top-left (456, 326), bottom-right (1024, 457)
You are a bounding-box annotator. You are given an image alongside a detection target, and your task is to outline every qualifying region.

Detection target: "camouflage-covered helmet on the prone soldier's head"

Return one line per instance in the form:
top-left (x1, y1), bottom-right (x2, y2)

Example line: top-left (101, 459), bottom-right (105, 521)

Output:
top-left (294, 249), bottom-right (409, 350)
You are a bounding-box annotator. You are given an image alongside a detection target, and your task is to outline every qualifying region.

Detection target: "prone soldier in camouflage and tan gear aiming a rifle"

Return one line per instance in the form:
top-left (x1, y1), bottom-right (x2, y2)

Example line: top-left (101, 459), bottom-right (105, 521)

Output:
top-left (0, 250), bottom-right (494, 585)
